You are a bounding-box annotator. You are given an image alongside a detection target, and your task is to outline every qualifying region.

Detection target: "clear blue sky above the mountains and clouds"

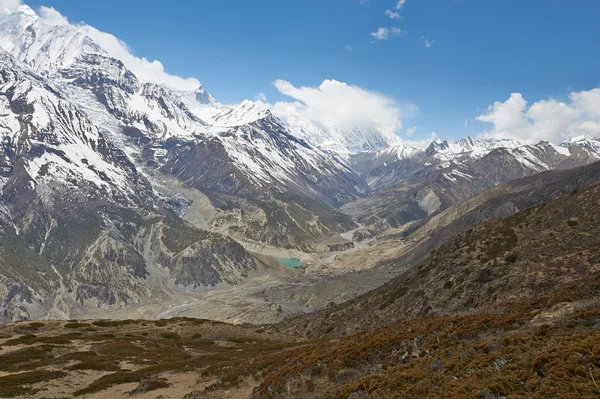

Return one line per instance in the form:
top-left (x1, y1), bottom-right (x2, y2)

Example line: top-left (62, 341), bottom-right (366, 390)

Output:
top-left (25, 0), bottom-right (600, 144)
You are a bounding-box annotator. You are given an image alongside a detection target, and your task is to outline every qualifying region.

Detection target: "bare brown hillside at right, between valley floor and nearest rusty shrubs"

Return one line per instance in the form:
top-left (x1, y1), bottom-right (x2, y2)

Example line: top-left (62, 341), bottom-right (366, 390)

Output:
top-left (279, 177), bottom-right (600, 337)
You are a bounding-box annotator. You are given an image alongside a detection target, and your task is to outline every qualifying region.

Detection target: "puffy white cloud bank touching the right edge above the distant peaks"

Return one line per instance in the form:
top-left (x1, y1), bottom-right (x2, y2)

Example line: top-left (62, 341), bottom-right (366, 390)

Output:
top-left (477, 88), bottom-right (600, 143)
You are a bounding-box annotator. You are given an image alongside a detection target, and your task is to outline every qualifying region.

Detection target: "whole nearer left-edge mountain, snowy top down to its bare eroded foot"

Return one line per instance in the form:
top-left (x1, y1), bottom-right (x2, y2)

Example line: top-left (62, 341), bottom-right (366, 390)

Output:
top-left (0, 49), bottom-right (260, 320)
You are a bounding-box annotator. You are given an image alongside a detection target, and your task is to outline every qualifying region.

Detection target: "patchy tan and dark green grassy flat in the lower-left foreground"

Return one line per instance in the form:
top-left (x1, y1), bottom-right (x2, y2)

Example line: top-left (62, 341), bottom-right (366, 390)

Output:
top-left (0, 318), bottom-right (287, 397)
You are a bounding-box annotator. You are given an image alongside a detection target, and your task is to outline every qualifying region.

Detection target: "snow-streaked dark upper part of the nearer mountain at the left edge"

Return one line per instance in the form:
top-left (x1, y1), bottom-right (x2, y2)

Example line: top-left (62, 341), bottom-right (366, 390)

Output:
top-left (0, 50), bottom-right (149, 208)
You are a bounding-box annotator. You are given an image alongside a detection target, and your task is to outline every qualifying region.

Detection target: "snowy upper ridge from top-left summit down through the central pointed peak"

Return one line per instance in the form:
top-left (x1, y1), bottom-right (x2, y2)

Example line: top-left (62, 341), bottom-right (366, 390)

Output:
top-left (0, 6), bottom-right (360, 199)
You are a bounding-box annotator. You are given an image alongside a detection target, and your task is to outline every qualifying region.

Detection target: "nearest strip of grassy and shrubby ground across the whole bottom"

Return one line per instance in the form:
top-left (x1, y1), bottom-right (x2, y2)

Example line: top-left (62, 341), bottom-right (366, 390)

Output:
top-left (0, 260), bottom-right (600, 399)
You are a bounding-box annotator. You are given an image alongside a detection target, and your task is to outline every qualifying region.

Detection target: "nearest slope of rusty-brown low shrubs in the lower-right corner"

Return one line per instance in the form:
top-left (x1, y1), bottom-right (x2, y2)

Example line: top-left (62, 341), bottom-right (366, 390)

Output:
top-left (213, 290), bottom-right (600, 398)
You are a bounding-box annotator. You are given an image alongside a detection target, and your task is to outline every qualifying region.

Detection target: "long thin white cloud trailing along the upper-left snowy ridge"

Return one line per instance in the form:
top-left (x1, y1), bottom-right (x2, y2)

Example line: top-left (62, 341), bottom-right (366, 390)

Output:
top-left (34, 6), bottom-right (200, 90)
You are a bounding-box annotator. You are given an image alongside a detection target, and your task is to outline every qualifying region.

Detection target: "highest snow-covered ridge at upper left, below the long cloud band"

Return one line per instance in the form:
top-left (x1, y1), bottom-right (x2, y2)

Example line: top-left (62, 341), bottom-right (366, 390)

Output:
top-left (0, 6), bottom-right (212, 142)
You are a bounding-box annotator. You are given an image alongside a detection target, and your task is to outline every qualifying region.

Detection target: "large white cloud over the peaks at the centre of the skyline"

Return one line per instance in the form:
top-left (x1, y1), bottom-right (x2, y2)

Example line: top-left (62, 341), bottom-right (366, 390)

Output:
top-left (273, 80), bottom-right (417, 133)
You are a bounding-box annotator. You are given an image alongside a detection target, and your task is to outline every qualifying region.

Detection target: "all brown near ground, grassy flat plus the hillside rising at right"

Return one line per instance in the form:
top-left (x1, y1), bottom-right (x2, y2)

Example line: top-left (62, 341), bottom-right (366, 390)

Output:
top-left (0, 151), bottom-right (600, 399)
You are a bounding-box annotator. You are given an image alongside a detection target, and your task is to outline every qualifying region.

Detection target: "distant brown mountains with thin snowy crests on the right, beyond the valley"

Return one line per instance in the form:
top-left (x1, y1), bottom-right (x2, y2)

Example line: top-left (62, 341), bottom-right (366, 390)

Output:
top-left (342, 140), bottom-right (597, 234)
